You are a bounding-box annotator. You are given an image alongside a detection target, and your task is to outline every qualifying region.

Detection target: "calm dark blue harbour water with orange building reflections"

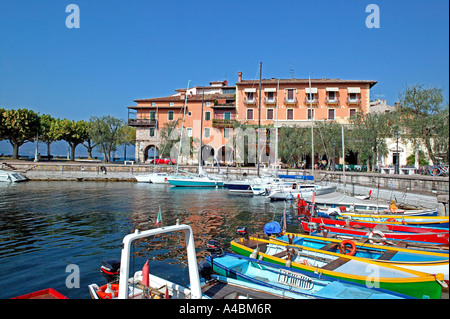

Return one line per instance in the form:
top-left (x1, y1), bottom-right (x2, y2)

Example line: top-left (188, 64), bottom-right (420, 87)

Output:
top-left (0, 181), bottom-right (297, 299)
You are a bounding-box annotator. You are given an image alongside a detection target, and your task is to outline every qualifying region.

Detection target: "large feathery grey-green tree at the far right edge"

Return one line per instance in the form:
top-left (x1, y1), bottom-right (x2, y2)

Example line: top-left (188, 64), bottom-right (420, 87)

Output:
top-left (397, 84), bottom-right (448, 163)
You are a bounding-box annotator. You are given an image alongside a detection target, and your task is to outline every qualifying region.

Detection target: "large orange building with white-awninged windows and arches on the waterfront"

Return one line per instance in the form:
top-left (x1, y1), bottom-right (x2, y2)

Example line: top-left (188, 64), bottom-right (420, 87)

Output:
top-left (128, 72), bottom-right (377, 163)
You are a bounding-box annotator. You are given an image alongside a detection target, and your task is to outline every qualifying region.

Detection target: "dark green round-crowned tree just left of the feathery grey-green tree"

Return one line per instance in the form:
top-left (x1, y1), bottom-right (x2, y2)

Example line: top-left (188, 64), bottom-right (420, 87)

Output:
top-left (54, 119), bottom-right (88, 161)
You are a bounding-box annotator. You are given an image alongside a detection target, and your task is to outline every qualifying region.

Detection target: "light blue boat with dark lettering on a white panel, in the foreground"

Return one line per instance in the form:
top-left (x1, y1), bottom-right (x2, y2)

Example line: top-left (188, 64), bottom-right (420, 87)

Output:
top-left (206, 252), bottom-right (411, 299)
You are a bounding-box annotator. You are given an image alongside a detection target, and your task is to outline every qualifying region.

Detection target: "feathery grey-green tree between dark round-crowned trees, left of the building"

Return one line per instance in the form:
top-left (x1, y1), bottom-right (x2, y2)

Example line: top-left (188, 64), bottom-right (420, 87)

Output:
top-left (88, 115), bottom-right (124, 163)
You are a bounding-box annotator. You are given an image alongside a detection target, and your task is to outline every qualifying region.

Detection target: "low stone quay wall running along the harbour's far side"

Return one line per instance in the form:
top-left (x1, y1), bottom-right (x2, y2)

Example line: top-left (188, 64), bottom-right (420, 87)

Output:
top-left (0, 160), bottom-right (449, 215)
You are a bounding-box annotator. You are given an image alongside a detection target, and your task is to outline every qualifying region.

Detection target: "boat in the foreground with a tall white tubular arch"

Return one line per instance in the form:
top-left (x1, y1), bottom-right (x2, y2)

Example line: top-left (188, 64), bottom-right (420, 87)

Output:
top-left (88, 225), bottom-right (293, 299)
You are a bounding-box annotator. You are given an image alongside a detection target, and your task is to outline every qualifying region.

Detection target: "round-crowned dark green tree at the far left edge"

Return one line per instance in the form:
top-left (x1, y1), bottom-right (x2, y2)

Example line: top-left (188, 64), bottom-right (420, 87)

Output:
top-left (0, 108), bottom-right (40, 159)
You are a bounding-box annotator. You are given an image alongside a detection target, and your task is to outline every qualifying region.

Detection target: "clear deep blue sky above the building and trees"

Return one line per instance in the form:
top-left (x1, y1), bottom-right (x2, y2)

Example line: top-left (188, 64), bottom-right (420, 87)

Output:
top-left (0, 0), bottom-right (449, 158)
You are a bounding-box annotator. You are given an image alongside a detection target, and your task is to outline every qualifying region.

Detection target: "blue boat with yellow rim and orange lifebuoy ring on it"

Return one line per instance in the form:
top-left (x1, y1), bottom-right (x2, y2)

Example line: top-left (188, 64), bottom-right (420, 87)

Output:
top-left (269, 228), bottom-right (449, 282)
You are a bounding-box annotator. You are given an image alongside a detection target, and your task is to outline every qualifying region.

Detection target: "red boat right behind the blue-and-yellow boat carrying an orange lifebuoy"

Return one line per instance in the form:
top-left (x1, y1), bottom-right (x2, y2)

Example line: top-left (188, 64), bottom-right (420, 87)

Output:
top-left (302, 217), bottom-right (449, 245)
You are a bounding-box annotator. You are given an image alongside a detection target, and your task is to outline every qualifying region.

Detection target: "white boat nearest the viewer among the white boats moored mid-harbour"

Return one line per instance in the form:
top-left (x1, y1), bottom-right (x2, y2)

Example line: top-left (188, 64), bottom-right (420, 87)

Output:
top-left (267, 183), bottom-right (336, 200)
